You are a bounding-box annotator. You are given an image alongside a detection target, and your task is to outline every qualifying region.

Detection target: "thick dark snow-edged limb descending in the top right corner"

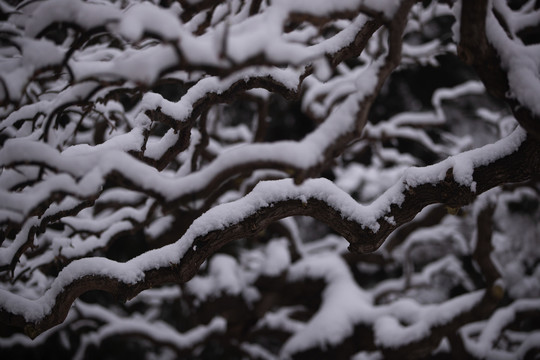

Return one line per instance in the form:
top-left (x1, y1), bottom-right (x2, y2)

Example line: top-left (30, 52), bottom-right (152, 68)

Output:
top-left (458, 0), bottom-right (540, 137)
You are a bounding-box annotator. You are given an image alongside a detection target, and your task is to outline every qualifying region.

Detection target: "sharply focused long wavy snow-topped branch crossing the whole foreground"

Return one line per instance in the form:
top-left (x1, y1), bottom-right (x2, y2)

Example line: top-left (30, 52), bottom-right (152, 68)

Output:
top-left (0, 129), bottom-right (540, 336)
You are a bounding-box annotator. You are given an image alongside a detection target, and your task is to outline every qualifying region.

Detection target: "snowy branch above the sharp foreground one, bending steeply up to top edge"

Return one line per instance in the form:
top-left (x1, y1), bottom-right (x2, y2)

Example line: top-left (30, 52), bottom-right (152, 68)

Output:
top-left (0, 1), bottom-right (414, 232)
